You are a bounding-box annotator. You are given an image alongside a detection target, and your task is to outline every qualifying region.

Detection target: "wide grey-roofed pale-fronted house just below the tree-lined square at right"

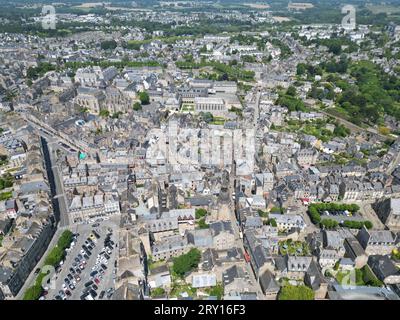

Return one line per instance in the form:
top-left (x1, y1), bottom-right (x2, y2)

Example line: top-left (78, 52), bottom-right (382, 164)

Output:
top-left (357, 226), bottom-right (396, 255)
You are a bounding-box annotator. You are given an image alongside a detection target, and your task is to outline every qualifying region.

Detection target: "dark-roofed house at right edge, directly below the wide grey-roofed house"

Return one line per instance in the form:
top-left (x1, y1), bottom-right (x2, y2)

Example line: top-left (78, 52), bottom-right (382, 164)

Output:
top-left (368, 255), bottom-right (400, 284)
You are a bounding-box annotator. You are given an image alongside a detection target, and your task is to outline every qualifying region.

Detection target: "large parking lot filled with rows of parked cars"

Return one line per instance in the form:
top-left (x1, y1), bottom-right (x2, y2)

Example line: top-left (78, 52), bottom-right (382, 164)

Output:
top-left (46, 222), bottom-right (118, 300)
